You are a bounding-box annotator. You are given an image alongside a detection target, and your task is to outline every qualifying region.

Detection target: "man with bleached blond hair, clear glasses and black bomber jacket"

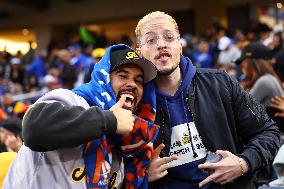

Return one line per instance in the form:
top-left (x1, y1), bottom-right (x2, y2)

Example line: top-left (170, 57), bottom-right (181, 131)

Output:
top-left (135, 11), bottom-right (279, 189)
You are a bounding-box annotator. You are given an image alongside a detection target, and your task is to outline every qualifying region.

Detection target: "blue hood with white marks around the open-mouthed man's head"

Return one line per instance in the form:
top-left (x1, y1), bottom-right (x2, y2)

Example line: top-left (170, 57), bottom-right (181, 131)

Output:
top-left (73, 44), bottom-right (156, 116)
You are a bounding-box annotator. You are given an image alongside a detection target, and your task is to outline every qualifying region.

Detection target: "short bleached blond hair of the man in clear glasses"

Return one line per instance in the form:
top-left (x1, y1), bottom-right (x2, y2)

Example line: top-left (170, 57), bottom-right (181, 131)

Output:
top-left (135, 11), bottom-right (179, 44)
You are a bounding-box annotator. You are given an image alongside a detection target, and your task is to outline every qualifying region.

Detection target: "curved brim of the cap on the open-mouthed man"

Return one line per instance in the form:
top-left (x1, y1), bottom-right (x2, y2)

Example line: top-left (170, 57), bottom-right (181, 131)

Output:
top-left (114, 58), bottom-right (157, 83)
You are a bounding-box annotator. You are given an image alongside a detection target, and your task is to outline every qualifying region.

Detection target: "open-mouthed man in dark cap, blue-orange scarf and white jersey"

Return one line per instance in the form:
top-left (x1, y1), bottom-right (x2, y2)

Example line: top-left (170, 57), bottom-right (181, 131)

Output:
top-left (3, 45), bottom-right (159, 189)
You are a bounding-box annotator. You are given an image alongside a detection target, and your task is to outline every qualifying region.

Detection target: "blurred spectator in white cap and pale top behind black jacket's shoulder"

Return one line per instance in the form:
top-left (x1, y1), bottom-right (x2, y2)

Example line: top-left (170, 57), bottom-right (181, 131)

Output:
top-left (217, 36), bottom-right (241, 78)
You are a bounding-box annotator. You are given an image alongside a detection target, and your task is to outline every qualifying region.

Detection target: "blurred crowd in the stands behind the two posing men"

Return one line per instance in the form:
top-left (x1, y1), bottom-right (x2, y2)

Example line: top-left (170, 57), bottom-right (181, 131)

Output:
top-left (0, 0), bottom-right (284, 188)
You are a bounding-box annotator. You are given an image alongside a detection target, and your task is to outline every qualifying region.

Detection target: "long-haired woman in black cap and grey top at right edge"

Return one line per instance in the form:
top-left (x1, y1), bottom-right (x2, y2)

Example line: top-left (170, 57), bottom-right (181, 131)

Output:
top-left (236, 43), bottom-right (283, 107)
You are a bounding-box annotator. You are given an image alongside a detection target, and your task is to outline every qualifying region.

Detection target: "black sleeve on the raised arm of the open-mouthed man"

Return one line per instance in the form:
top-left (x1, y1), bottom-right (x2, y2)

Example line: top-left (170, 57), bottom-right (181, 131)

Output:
top-left (23, 89), bottom-right (117, 151)
